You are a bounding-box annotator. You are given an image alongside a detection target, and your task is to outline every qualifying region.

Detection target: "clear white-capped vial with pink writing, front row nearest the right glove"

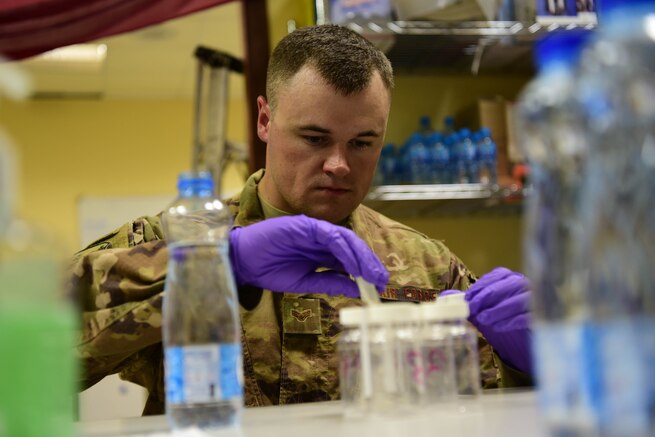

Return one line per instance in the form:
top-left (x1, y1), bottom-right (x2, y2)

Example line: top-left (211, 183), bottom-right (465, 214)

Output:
top-left (420, 302), bottom-right (457, 407)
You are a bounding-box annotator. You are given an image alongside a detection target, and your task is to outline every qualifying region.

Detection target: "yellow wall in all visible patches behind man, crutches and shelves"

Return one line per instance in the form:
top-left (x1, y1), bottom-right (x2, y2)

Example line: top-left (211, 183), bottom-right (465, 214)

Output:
top-left (0, 0), bottom-right (525, 273)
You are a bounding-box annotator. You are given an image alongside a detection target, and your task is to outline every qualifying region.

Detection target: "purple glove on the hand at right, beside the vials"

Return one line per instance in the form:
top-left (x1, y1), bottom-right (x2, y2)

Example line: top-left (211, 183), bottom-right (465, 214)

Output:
top-left (466, 267), bottom-right (532, 374)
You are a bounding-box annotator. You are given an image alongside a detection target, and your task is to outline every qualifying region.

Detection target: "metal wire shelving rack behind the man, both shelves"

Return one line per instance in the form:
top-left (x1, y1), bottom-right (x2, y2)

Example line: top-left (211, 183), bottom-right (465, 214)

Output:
top-left (316, 10), bottom-right (595, 217)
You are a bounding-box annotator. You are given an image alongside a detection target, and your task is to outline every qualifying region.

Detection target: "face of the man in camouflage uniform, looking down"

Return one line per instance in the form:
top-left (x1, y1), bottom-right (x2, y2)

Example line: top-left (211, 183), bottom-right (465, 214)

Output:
top-left (257, 66), bottom-right (390, 223)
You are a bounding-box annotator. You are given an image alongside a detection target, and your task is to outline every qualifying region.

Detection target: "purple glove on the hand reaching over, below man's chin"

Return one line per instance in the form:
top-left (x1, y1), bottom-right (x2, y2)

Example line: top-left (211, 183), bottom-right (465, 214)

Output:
top-left (230, 215), bottom-right (389, 297)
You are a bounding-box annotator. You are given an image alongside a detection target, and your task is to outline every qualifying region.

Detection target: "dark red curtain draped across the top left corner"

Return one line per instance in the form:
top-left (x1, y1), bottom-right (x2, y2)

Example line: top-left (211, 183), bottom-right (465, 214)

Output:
top-left (0, 0), bottom-right (231, 59)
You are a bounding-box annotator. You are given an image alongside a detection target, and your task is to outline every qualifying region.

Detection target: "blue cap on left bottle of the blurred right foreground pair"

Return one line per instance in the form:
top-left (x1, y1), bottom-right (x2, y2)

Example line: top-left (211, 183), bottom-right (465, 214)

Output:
top-left (535, 29), bottom-right (593, 71)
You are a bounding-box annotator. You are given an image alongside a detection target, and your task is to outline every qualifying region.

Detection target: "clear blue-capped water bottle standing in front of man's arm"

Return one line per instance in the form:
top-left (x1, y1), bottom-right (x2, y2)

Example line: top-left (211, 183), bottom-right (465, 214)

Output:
top-left (163, 172), bottom-right (243, 429)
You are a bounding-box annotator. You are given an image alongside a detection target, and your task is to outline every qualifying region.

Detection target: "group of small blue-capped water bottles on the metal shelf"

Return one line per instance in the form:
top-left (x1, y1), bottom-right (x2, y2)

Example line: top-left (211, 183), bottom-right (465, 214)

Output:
top-left (374, 116), bottom-right (496, 185)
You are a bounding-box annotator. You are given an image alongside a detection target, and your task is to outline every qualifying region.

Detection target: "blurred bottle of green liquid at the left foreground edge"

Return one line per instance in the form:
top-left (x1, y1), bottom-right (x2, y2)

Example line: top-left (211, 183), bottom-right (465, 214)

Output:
top-left (0, 136), bottom-right (77, 437)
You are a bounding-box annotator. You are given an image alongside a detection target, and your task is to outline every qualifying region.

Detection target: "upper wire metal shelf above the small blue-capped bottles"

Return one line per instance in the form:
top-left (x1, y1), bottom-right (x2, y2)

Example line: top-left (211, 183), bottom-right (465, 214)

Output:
top-left (347, 21), bottom-right (595, 75)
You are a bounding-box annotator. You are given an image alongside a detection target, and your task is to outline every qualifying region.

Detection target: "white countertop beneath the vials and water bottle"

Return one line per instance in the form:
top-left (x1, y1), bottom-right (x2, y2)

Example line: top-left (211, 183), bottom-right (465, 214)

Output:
top-left (78, 390), bottom-right (548, 437)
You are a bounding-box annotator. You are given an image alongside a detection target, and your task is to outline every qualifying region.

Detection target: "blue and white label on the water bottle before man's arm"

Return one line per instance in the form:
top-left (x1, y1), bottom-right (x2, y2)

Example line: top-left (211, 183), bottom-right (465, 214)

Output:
top-left (166, 343), bottom-right (243, 404)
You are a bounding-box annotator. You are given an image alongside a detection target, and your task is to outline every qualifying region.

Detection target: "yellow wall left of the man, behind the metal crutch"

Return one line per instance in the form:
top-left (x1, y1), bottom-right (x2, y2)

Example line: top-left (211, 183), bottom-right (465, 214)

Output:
top-left (0, 96), bottom-right (246, 252)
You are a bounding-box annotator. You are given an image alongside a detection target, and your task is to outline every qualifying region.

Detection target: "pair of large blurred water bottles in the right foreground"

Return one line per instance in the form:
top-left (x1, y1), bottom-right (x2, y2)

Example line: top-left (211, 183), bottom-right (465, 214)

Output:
top-left (518, 0), bottom-right (655, 437)
